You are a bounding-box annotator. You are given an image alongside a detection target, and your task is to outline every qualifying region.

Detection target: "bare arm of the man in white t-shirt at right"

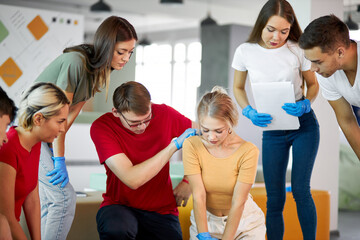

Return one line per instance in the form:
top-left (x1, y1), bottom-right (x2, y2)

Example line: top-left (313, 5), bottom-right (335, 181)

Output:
top-left (329, 97), bottom-right (360, 160)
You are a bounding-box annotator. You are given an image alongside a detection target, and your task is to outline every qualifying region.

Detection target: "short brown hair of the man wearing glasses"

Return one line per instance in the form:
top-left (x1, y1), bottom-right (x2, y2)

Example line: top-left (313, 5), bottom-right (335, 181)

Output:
top-left (113, 81), bottom-right (151, 115)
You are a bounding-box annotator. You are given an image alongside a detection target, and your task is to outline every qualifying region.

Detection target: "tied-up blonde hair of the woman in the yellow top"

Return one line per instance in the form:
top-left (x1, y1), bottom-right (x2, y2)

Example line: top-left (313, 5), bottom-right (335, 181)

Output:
top-left (197, 86), bottom-right (239, 127)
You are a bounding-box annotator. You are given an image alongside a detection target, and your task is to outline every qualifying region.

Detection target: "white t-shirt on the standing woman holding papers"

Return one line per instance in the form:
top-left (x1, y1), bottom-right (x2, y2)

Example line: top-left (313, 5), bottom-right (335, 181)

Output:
top-left (232, 41), bottom-right (311, 100)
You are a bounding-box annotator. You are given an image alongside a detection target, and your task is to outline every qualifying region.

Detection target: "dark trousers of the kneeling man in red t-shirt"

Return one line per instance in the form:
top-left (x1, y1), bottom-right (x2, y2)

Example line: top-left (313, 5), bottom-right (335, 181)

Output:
top-left (96, 204), bottom-right (182, 240)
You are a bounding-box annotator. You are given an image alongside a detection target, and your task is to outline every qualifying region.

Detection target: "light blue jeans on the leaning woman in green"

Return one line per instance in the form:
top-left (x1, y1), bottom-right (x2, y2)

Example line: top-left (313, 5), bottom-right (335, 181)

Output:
top-left (39, 142), bottom-right (76, 240)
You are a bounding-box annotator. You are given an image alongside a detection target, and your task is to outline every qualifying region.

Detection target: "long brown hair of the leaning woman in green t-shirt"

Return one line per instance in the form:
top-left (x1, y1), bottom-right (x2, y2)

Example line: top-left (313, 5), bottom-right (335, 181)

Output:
top-left (64, 16), bottom-right (138, 96)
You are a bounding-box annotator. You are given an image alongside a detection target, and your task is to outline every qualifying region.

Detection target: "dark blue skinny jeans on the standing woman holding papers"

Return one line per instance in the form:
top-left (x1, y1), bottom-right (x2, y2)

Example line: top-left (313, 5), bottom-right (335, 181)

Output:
top-left (262, 110), bottom-right (320, 240)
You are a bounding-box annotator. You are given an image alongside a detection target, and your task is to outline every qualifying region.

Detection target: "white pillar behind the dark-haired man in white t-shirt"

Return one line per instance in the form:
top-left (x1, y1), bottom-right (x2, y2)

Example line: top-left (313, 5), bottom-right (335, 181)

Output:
top-left (289, 0), bottom-right (344, 230)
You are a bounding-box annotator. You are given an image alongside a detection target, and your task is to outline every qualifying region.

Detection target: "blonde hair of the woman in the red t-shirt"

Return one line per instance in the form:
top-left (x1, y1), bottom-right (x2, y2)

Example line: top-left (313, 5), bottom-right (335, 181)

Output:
top-left (19, 83), bottom-right (70, 130)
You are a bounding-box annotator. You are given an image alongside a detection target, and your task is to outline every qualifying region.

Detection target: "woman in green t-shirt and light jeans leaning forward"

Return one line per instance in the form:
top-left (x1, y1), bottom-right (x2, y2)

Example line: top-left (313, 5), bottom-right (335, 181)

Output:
top-left (35, 16), bottom-right (137, 239)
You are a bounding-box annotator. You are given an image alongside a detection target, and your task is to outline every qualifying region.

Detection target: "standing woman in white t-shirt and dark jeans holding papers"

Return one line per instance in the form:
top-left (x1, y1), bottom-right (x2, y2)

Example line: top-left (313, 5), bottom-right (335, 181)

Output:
top-left (232, 0), bottom-right (319, 240)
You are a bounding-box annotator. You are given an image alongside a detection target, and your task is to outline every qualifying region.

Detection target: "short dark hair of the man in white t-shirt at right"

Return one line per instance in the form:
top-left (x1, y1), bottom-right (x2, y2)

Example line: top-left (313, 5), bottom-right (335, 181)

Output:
top-left (299, 14), bottom-right (350, 53)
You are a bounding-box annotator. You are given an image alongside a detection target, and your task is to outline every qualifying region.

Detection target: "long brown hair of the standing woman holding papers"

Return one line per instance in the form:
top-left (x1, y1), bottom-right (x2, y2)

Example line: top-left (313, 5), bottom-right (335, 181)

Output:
top-left (247, 0), bottom-right (302, 43)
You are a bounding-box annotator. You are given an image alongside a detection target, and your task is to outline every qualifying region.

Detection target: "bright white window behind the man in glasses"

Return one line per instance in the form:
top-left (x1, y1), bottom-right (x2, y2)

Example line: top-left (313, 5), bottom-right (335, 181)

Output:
top-left (135, 41), bottom-right (201, 120)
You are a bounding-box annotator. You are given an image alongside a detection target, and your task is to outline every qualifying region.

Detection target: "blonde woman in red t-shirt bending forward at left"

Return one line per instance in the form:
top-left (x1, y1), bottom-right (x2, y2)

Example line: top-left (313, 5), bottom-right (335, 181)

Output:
top-left (0, 83), bottom-right (70, 239)
